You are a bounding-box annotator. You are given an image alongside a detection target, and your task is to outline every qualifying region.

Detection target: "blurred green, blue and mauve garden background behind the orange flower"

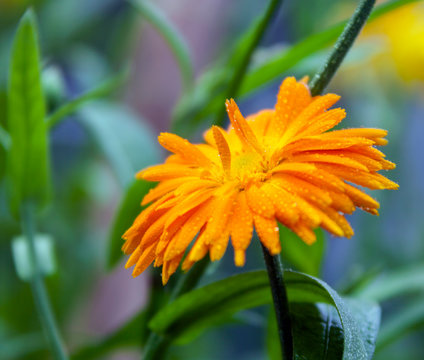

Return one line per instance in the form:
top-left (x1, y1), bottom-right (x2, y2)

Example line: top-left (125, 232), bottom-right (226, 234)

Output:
top-left (0, 0), bottom-right (424, 360)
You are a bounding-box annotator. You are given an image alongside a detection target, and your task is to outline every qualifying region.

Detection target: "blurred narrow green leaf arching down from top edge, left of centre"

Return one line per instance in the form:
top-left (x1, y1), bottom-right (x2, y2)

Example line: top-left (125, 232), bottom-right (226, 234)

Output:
top-left (130, 0), bottom-right (194, 91)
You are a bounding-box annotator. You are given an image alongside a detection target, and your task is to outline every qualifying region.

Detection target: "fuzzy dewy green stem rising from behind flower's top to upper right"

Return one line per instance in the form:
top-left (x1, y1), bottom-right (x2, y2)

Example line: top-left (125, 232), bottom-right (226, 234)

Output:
top-left (309, 0), bottom-right (375, 96)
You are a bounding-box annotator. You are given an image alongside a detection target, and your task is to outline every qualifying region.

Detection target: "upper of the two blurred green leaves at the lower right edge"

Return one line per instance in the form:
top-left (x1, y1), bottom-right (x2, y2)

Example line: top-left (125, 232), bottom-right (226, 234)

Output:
top-left (353, 264), bottom-right (424, 302)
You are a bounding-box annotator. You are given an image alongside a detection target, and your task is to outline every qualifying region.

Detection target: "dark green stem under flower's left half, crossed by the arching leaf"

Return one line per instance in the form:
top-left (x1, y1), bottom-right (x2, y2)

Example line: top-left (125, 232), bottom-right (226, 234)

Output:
top-left (143, 258), bottom-right (210, 360)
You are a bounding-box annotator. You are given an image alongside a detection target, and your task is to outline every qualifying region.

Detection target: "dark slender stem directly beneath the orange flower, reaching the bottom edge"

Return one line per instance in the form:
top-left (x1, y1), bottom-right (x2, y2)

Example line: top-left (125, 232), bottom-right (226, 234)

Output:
top-left (261, 244), bottom-right (293, 360)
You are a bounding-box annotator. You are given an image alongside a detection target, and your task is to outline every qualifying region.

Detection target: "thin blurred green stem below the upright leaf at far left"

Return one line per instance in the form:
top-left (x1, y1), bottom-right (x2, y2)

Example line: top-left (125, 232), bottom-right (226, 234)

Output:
top-left (22, 204), bottom-right (68, 360)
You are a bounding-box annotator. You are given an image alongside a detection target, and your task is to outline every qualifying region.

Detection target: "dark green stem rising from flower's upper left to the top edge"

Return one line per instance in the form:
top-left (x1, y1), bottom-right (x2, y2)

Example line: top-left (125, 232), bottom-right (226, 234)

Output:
top-left (214, 0), bottom-right (283, 126)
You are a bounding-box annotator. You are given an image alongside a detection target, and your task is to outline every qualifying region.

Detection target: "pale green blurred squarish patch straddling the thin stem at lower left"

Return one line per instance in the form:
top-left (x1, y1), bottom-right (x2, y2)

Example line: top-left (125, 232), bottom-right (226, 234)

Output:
top-left (12, 234), bottom-right (56, 281)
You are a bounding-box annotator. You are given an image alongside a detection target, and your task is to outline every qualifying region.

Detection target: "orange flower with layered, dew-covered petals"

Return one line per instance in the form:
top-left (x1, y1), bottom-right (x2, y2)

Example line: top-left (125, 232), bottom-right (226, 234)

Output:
top-left (122, 77), bottom-right (398, 284)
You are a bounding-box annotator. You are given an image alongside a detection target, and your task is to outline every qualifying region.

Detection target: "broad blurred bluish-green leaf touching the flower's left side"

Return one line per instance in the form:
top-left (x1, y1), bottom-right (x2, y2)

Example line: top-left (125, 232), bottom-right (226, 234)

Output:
top-left (78, 101), bottom-right (159, 187)
